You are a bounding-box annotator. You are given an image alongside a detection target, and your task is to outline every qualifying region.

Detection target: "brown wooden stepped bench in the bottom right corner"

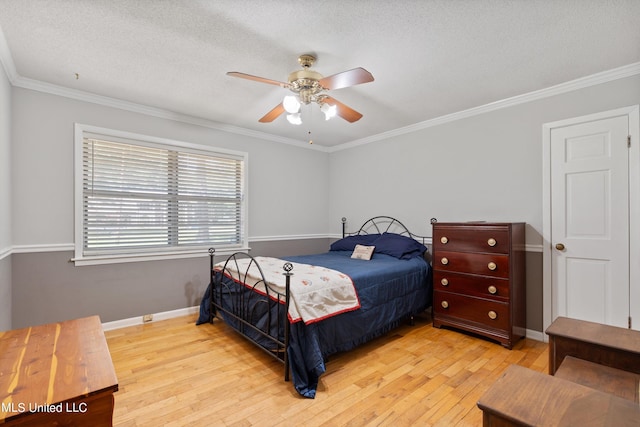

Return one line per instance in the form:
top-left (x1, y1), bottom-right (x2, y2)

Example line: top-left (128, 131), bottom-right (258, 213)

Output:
top-left (478, 317), bottom-right (640, 427)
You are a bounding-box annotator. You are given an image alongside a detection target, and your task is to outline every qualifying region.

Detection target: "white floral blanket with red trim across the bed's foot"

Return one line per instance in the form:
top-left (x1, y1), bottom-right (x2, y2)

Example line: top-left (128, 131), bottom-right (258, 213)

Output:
top-left (215, 257), bottom-right (360, 324)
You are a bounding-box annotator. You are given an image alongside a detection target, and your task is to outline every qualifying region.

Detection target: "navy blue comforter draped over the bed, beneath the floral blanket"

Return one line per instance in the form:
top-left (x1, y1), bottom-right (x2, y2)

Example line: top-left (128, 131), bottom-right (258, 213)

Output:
top-left (198, 251), bottom-right (432, 398)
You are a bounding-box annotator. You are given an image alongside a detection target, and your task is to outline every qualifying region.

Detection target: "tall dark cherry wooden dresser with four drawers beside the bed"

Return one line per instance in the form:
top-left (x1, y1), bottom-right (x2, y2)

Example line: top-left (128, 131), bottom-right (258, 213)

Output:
top-left (432, 222), bottom-right (526, 349)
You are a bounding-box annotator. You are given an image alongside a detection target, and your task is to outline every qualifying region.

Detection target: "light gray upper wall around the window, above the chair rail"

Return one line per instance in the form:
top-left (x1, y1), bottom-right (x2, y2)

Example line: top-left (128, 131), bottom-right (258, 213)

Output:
top-left (12, 88), bottom-right (329, 248)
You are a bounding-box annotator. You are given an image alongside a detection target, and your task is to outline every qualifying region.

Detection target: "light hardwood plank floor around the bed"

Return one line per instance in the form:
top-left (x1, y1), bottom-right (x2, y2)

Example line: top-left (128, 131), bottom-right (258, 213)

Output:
top-left (106, 315), bottom-right (549, 427)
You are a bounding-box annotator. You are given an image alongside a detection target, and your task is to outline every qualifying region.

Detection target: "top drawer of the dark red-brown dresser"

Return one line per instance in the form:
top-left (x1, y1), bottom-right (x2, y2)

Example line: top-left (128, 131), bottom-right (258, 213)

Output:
top-left (433, 225), bottom-right (511, 254)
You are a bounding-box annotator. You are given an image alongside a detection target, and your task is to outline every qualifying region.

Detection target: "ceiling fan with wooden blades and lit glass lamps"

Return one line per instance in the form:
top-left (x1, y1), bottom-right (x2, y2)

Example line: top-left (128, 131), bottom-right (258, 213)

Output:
top-left (227, 54), bottom-right (373, 124)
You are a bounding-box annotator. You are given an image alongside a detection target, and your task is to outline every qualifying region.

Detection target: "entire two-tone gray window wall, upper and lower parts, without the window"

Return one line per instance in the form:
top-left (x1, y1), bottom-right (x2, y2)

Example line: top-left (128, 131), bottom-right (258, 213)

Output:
top-left (8, 88), bottom-right (329, 328)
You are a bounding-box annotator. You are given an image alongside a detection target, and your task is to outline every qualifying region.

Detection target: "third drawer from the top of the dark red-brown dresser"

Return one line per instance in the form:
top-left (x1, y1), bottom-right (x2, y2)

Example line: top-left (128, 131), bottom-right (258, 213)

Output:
top-left (433, 270), bottom-right (509, 302)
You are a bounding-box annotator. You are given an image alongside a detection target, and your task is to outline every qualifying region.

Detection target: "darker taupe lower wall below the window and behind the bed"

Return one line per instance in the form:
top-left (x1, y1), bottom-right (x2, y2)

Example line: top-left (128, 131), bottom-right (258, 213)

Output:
top-left (11, 239), bottom-right (329, 328)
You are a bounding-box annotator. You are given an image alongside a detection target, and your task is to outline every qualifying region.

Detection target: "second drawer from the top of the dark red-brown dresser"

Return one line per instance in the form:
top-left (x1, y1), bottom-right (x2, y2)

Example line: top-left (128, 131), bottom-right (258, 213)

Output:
top-left (433, 251), bottom-right (509, 278)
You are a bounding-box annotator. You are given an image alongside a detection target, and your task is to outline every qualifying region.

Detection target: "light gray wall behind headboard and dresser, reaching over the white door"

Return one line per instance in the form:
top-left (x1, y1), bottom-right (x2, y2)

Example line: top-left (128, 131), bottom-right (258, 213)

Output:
top-left (329, 75), bottom-right (640, 331)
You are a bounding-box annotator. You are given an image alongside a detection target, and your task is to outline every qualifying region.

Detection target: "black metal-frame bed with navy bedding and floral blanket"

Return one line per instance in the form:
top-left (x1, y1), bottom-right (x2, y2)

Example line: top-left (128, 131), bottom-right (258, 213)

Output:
top-left (197, 216), bottom-right (432, 398)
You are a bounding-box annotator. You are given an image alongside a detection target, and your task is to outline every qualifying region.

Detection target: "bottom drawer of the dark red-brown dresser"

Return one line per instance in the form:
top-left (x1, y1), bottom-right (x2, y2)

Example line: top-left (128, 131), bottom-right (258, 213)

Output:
top-left (433, 291), bottom-right (510, 331)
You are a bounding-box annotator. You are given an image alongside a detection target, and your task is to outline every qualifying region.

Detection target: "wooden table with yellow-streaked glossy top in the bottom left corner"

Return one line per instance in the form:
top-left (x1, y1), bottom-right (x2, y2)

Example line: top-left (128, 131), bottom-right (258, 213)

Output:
top-left (0, 316), bottom-right (118, 427)
